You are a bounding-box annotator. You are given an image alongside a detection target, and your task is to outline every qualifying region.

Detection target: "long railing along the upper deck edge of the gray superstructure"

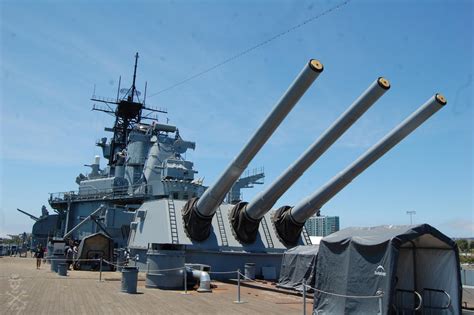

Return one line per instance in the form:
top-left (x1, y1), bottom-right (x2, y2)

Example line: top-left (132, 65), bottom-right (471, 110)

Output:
top-left (49, 185), bottom-right (152, 203)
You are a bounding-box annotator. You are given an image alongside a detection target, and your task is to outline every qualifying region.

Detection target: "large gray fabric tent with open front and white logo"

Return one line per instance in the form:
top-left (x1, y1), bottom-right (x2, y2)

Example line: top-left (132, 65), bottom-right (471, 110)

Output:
top-left (314, 224), bottom-right (462, 314)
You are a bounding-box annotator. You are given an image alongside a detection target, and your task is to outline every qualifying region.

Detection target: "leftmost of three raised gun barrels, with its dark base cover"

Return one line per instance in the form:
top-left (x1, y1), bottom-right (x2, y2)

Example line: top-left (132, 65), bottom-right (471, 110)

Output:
top-left (182, 59), bottom-right (323, 241)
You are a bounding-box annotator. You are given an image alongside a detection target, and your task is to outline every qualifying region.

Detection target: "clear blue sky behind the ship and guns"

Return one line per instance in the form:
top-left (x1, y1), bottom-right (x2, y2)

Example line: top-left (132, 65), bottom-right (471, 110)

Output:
top-left (0, 0), bottom-right (474, 236)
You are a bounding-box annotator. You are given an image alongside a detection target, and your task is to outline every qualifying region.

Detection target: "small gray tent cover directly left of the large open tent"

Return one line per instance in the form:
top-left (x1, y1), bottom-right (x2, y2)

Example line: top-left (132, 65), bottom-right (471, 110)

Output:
top-left (278, 245), bottom-right (319, 291)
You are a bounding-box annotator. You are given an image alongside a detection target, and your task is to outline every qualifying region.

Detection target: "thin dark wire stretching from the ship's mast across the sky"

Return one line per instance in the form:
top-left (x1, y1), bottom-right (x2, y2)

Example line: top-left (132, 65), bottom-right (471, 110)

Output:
top-left (148, 0), bottom-right (351, 98)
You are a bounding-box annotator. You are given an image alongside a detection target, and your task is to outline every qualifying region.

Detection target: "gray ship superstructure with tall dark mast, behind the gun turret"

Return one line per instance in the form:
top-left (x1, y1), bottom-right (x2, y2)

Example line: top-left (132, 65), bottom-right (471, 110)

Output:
top-left (42, 53), bottom-right (264, 252)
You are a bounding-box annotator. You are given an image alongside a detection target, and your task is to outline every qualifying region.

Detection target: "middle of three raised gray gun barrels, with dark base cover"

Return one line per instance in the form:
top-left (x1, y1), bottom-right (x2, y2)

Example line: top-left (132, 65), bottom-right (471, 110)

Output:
top-left (230, 77), bottom-right (390, 244)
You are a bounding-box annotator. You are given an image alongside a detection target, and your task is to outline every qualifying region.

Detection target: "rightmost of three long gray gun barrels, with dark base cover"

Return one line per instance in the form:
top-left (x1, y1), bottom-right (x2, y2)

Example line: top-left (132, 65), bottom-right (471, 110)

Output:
top-left (273, 94), bottom-right (447, 246)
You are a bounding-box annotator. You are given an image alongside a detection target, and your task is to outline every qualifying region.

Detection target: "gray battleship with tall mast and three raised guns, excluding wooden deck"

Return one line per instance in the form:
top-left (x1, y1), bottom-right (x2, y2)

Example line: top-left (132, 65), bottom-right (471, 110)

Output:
top-left (12, 53), bottom-right (461, 309)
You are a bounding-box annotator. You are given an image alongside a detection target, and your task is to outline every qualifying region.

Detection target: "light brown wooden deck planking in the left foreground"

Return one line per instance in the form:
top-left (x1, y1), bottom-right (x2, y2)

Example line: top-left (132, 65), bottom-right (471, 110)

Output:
top-left (0, 257), bottom-right (312, 315)
